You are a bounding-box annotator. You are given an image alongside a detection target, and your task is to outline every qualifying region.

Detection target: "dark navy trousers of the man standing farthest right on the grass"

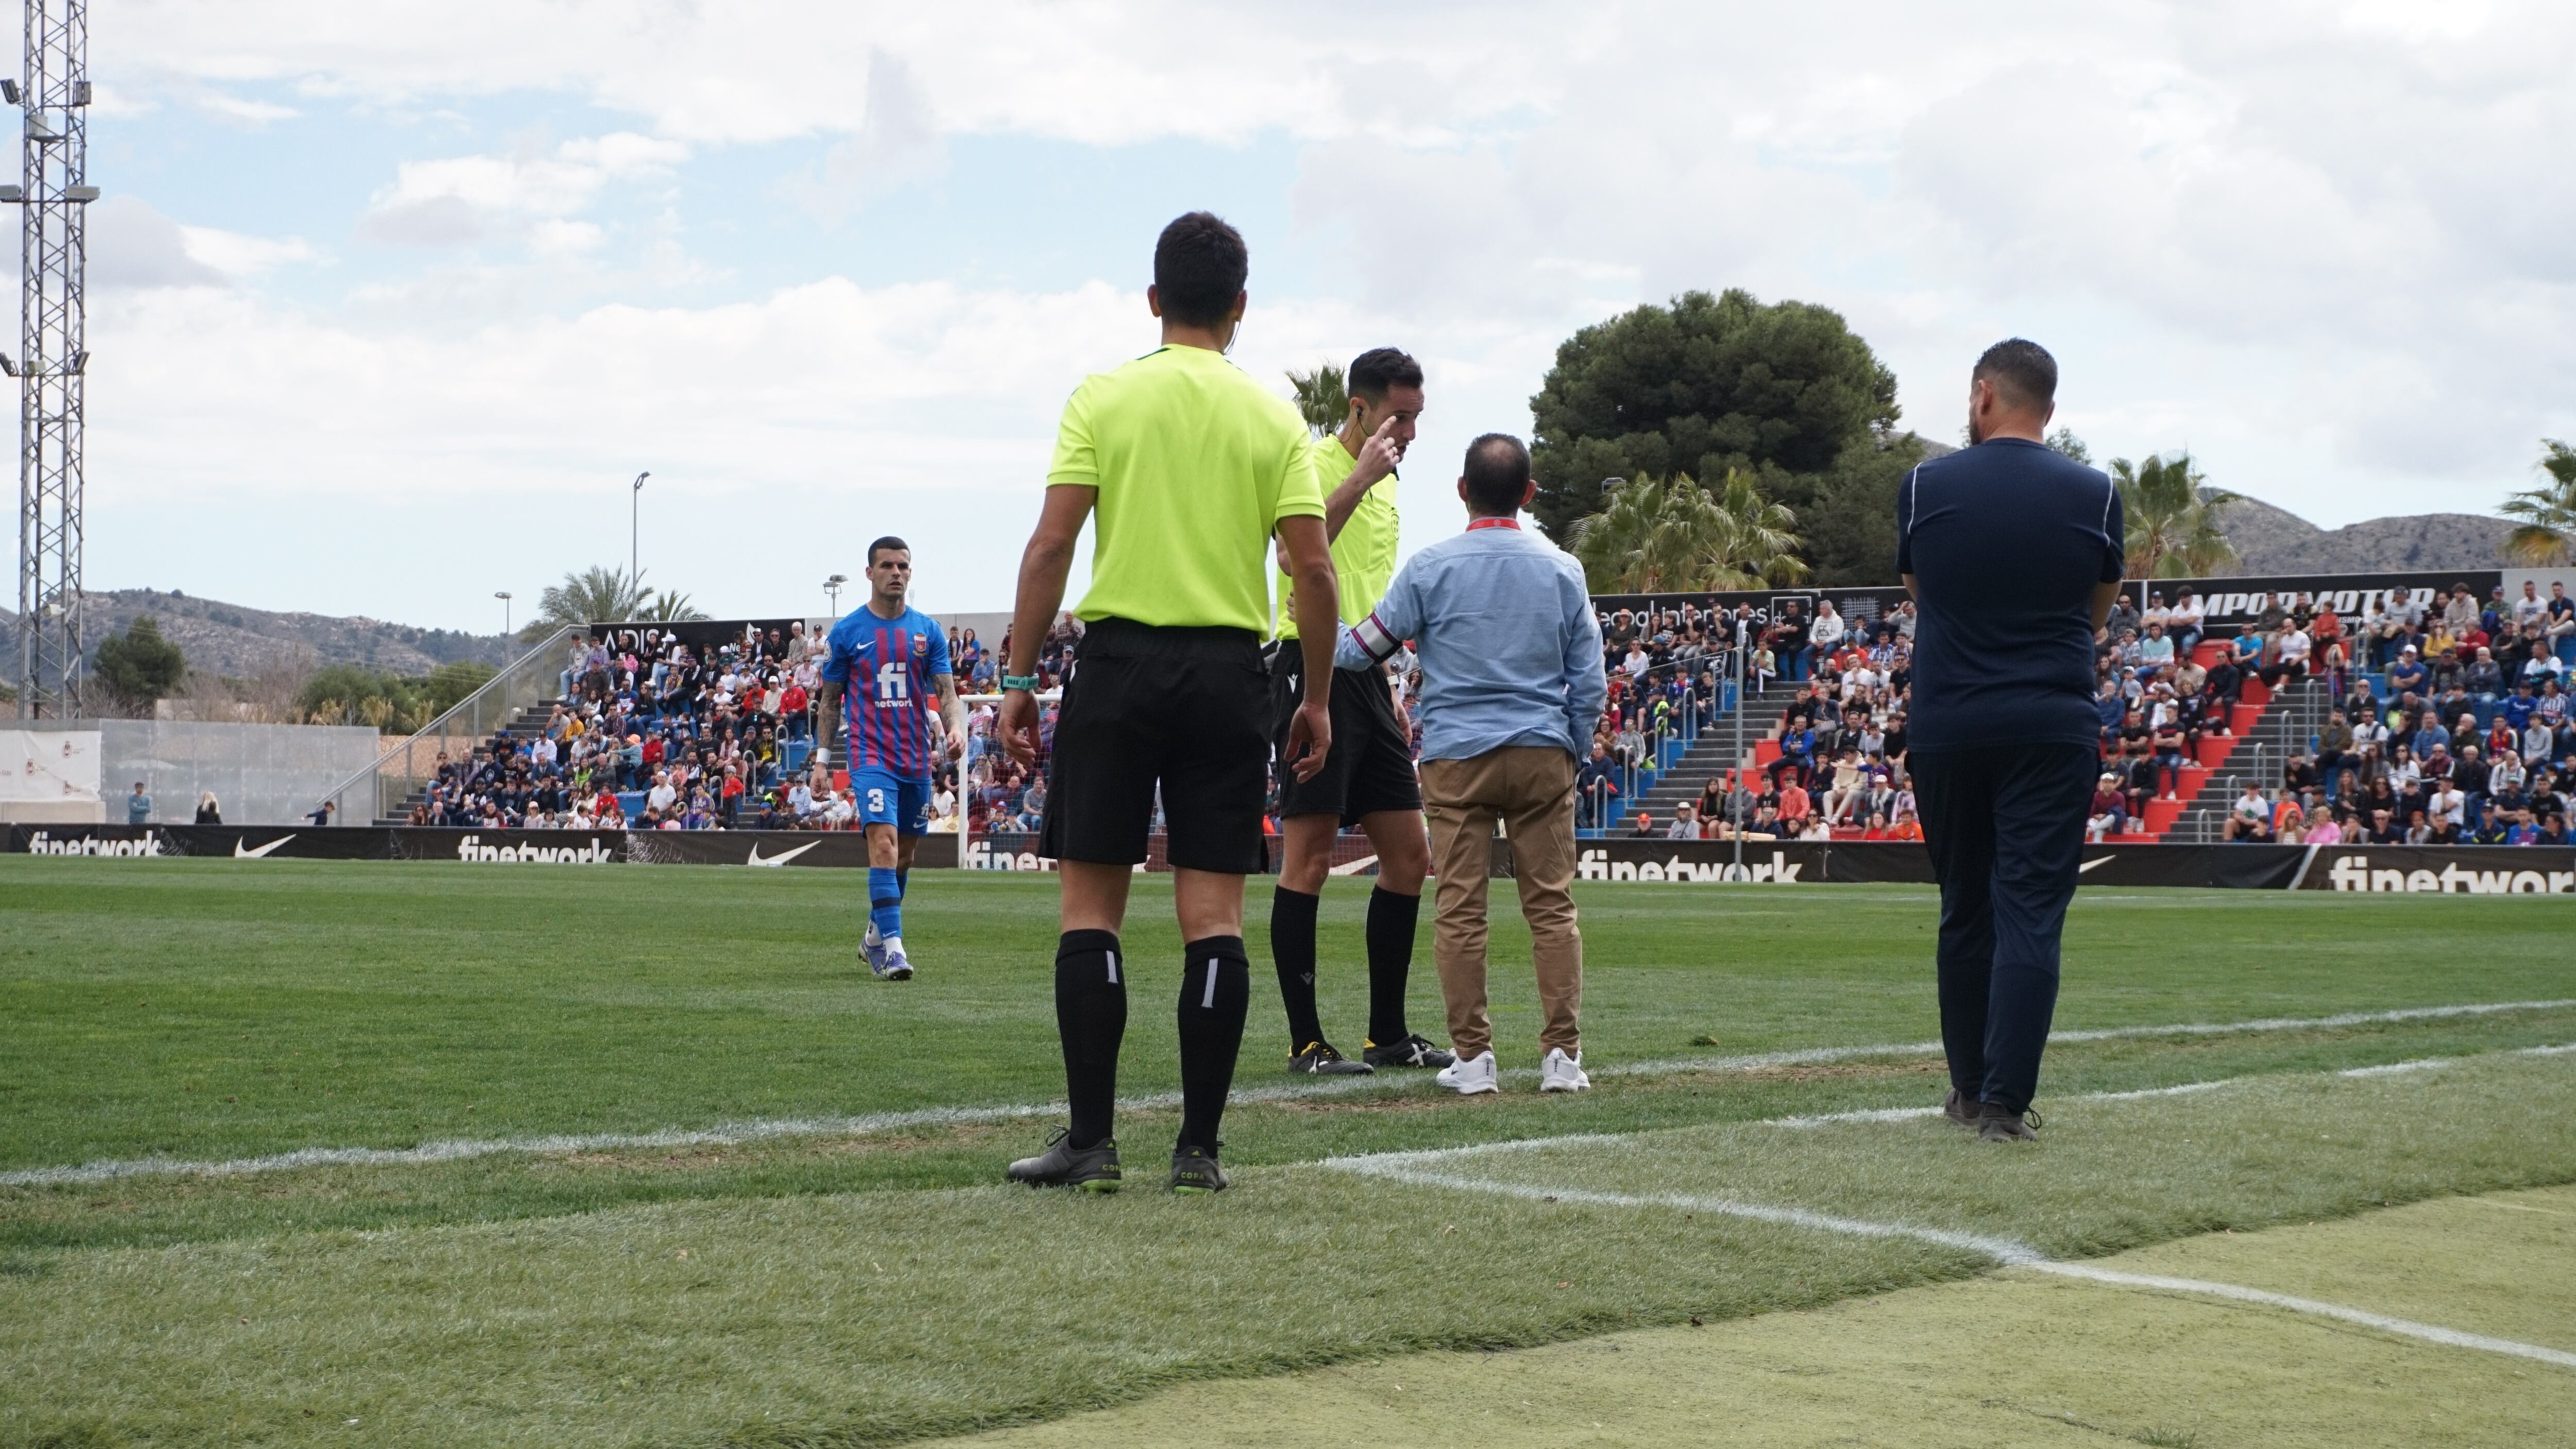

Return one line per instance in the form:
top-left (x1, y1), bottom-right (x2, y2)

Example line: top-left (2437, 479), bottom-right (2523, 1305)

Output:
top-left (1909, 744), bottom-right (2102, 1112)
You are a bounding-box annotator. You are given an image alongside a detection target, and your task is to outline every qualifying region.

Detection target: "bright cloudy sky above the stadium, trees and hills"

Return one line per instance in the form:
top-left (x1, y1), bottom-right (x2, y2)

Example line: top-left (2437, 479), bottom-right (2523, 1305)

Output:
top-left (55, 0), bottom-right (2576, 630)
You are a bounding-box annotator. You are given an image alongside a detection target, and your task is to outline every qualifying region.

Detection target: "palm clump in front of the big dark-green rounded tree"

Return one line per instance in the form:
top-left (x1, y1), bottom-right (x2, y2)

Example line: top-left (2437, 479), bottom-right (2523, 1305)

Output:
top-left (1571, 468), bottom-right (1806, 594)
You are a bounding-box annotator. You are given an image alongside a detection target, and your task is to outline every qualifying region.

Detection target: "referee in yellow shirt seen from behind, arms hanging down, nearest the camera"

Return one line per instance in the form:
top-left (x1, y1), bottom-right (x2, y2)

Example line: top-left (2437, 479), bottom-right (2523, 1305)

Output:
top-left (999, 211), bottom-right (1337, 1191)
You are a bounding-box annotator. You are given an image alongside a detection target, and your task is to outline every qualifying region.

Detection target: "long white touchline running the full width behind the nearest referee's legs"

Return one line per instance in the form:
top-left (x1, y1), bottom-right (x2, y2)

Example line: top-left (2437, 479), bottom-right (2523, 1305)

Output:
top-left (0, 999), bottom-right (2576, 1186)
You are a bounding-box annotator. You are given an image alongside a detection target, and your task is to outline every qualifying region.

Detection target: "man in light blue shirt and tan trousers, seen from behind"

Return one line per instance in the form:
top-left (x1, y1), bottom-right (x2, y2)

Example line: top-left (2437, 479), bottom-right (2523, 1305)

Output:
top-left (1334, 432), bottom-right (1610, 1094)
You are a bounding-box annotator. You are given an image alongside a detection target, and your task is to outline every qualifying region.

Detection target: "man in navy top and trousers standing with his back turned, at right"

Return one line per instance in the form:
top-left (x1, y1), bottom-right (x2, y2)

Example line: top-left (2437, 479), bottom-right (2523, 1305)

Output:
top-left (1896, 337), bottom-right (2125, 1143)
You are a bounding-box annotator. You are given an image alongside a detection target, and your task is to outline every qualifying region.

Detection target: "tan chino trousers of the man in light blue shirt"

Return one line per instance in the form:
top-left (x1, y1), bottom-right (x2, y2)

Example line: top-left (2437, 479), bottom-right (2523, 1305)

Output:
top-left (1422, 744), bottom-right (1584, 1061)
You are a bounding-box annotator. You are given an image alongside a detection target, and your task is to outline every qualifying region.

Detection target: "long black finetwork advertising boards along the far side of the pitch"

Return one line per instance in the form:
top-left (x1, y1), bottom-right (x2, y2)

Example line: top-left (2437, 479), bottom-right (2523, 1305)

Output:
top-left (15, 824), bottom-right (2576, 896)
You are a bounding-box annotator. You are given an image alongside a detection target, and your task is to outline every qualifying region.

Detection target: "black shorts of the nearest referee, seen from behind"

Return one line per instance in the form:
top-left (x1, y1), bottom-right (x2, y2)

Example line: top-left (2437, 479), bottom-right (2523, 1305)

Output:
top-left (1038, 618), bottom-right (1270, 875)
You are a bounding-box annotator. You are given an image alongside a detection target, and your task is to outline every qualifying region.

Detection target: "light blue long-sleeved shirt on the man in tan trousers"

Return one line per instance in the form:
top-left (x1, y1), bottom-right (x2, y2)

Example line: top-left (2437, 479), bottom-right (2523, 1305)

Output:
top-left (1334, 525), bottom-right (1610, 759)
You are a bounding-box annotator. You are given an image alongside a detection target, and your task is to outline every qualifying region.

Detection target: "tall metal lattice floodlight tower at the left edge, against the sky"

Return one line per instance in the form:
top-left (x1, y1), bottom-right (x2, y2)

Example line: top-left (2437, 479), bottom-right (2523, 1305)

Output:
top-left (0, 0), bottom-right (98, 718)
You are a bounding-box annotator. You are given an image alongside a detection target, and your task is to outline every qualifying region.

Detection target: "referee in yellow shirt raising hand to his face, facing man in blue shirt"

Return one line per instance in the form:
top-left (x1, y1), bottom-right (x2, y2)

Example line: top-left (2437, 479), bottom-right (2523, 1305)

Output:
top-left (1270, 348), bottom-right (1453, 1076)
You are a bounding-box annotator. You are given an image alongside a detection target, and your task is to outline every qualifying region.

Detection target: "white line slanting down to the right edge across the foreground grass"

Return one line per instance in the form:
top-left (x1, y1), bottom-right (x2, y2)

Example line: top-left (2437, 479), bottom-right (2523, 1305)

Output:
top-left (1327, 1158), bottom-right (2576, 1369)
